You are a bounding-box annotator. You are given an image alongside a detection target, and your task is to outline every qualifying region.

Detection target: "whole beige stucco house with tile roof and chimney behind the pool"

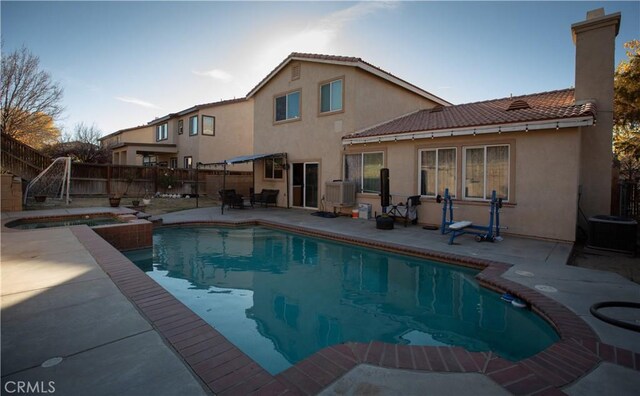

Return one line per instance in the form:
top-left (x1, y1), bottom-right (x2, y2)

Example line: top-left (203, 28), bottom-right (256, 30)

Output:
top-left (248, 9), bottom-right (620, 241)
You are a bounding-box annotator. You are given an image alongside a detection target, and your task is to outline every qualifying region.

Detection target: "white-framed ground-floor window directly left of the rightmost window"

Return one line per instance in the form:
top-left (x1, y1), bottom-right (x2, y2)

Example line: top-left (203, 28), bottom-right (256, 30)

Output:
top-left (418, 148), bottom-right (457, 197)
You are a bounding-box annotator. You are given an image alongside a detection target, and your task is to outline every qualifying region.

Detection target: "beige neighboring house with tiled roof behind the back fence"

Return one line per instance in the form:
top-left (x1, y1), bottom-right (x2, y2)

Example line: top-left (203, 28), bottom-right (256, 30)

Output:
top-left (100, 98), bottom-right (253, 170)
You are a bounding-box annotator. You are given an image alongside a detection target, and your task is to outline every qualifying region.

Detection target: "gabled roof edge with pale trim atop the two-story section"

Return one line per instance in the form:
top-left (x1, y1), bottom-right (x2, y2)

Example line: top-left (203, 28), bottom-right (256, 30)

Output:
top-left (247, 52), bottom-right (450, 104)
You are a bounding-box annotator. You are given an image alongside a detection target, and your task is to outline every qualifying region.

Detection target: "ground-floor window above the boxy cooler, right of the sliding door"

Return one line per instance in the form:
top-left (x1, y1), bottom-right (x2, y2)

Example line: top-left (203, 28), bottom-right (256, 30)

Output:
top-left (344, 151), bottom-right (384, 193)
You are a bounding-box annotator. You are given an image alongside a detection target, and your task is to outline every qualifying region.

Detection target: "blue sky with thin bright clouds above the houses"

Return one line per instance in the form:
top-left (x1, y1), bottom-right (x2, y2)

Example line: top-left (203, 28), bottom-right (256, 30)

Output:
top-left (0, 0), bottom-right (640, 135)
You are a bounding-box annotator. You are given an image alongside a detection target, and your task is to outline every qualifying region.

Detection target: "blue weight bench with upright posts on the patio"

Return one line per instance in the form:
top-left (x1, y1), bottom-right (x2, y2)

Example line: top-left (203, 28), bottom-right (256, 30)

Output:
top-left (436, 188), bottom-right (502, 245)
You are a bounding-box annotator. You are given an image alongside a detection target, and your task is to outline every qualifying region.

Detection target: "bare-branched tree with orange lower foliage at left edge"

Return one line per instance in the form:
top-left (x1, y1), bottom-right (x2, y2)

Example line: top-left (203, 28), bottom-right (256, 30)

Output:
top-left (0, 47), bottom-right (64, 146)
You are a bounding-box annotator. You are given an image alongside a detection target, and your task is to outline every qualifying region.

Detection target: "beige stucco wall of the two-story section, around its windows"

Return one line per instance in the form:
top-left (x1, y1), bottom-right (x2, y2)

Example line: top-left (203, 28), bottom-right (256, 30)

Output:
top-left (254, 62), bottom-right (434, 206)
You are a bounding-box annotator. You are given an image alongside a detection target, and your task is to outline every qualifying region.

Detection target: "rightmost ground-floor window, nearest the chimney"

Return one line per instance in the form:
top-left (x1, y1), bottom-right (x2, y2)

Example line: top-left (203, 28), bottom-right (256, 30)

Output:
top-left (462, 144), bottom-right (510, 201)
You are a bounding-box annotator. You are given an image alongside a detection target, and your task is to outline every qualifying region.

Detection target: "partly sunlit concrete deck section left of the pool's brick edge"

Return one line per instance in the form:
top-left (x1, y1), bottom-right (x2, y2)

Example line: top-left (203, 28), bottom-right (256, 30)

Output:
top-left (0, 226), bottom-right (207, 395)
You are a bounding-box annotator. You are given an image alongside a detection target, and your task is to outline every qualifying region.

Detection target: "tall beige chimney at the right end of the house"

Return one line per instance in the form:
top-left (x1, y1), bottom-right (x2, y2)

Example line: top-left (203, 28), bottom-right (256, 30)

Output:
top-left (571, 8), bottom-right (620, 217)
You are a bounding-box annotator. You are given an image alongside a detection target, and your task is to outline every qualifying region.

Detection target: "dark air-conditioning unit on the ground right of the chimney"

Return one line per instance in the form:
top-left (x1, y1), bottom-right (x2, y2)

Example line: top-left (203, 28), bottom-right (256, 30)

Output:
top-left (587, 215), bottom-right (638, 254)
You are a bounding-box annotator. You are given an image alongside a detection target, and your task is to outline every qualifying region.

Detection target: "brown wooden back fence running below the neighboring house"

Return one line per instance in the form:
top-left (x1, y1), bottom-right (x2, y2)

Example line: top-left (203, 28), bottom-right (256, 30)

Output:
top-left (71, 163), bottom-right (252, 197)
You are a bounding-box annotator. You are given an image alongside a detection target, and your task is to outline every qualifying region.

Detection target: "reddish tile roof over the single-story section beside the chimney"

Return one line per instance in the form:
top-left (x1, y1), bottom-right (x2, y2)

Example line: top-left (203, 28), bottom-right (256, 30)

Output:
top-left (343, 88), bottom-right (596, 139)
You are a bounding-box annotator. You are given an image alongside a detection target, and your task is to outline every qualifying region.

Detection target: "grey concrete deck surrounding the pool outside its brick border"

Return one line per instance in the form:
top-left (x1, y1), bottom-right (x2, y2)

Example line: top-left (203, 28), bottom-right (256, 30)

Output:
top-left (0, 208), bottom-right (640, 395)
